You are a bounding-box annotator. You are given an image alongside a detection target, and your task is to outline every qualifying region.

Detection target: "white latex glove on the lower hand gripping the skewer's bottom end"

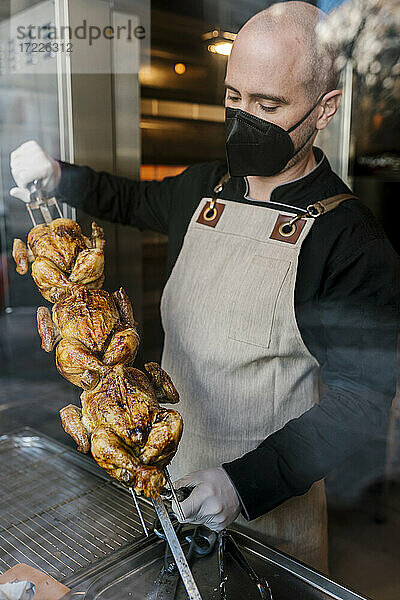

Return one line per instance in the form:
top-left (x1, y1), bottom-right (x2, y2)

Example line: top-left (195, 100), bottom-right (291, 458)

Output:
top-left (172, 467), bottom-right (240, 531)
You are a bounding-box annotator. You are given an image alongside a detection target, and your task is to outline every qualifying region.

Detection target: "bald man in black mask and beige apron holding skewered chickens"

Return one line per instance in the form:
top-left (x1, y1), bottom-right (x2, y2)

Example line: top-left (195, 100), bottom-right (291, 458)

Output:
top-left (11, 2), bottom-right (400, 569)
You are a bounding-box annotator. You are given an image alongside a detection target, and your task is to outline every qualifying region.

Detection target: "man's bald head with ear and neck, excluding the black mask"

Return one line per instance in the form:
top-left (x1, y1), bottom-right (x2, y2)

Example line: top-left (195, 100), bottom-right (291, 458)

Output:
top-left (225, 2), bottom-right (341, 172)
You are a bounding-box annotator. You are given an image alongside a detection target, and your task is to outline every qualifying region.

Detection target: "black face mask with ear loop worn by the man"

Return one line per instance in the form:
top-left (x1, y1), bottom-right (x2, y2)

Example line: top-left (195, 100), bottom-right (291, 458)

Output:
top-left (225, 94), bottom-right (325, 177)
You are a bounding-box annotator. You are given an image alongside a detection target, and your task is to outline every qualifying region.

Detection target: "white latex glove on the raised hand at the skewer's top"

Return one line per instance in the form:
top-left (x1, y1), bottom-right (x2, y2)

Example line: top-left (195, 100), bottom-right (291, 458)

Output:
top-left (10, 140), bottom-right (61, 202)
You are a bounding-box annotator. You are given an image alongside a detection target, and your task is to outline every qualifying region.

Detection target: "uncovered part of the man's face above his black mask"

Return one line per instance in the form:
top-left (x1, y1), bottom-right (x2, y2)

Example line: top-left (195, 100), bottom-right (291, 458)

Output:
top-left (225, 28), bottom-right (317, 158)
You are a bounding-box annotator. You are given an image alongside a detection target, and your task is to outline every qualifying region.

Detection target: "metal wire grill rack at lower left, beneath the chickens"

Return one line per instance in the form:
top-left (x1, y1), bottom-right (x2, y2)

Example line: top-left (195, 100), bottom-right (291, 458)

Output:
top-left (0, 429), bottom-right (154, 581)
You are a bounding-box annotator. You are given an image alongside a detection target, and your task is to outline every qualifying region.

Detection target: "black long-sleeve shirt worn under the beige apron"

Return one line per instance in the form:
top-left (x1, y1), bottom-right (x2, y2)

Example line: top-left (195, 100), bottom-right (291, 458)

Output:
top-left (58, 148), bottom-right (400, 519)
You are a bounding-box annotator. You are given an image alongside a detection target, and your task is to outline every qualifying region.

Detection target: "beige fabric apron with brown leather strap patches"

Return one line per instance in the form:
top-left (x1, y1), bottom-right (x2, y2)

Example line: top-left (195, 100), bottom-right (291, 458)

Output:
top-left (161, 198), bottom-right (334, 571)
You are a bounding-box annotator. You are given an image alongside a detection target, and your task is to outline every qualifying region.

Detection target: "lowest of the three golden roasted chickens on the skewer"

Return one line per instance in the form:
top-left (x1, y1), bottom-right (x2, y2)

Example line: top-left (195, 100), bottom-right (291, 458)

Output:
top-left (56, 330), bottom-right (183, 497)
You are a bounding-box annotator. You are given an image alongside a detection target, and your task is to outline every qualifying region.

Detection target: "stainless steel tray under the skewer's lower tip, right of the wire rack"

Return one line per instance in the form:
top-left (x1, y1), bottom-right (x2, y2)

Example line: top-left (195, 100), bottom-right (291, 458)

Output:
top-left (68, 527), bottom-right (366, 600)
